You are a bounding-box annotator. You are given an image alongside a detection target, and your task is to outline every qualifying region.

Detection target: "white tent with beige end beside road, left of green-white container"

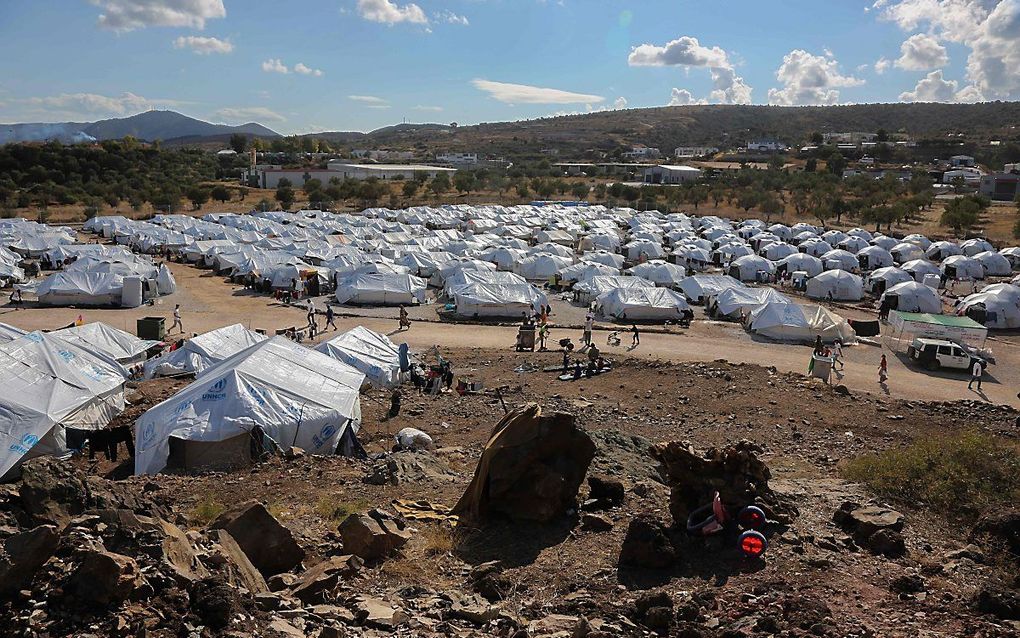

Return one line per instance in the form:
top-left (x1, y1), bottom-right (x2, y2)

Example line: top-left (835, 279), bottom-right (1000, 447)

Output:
top-left (748, 303), bottom-right (857, 343)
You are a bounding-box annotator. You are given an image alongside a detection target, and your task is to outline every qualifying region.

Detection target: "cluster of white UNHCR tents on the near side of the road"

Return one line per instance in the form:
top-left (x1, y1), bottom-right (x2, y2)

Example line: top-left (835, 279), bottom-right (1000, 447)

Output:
top-left (0, 316), bottom-right (407, 476)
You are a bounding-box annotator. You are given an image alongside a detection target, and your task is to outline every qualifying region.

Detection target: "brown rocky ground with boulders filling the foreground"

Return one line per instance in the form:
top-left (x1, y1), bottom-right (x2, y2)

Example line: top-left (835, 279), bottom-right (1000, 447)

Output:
top-left (0, 364), bottom-right (1020, 638)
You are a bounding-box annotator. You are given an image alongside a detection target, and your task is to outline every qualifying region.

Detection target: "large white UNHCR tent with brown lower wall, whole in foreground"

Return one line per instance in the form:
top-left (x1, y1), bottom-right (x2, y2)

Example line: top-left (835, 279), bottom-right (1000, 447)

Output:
top-left (135, 337), bottom-right (365, 475)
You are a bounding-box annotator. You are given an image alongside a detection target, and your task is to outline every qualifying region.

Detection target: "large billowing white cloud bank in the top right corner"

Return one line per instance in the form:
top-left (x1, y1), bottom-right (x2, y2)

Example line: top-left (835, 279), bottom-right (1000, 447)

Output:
top-left (876, 0), bottom-right (1020, 101)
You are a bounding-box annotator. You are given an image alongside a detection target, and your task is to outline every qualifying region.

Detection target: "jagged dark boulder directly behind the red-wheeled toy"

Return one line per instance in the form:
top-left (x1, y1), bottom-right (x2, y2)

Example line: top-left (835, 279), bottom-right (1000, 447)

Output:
top-left (652, 441), bottom-right (799, 527)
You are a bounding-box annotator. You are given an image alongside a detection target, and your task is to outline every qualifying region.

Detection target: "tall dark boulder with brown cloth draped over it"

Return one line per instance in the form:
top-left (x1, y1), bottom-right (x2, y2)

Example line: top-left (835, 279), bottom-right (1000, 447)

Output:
top-left (453, 403), bottom-right (595, 523)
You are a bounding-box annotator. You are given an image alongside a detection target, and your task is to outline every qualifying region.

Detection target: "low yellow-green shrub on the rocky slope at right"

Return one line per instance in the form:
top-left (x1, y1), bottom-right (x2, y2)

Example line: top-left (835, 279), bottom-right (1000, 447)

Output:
top-left (844, 430), bottom-right (1020, 518)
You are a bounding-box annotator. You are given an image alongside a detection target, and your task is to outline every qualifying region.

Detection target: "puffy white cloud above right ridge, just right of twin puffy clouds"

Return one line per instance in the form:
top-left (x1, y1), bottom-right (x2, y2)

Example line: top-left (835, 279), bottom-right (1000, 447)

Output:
top-left (768, 49), bottom-right (864, 106)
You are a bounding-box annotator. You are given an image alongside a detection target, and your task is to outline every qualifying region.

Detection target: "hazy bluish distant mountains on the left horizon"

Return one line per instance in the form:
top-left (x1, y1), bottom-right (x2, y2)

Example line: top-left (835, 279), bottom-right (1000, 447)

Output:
top-left (0, 110), bottom-right (279, 144)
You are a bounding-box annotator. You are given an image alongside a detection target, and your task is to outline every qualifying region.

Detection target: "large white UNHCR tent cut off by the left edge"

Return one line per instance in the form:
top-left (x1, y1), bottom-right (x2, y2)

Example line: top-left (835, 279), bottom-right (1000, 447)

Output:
top-left (0, 332), bottom-right (128, 476)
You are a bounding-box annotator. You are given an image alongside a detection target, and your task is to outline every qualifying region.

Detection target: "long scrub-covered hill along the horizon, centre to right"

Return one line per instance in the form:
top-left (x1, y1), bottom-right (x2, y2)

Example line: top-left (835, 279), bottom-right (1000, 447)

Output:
top-left (306, 102), bottom-right (1020, 158)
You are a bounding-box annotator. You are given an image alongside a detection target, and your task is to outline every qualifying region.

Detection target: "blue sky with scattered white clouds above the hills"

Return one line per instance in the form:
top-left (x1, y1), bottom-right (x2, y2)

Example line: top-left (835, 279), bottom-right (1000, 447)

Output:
top-left (0, 0), bottom-right (1020, 134)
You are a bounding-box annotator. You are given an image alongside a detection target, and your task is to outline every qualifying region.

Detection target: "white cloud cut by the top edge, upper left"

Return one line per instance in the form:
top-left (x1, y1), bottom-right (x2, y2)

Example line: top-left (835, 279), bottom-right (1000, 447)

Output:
top-left (92, 0), bottom-right (226, 33)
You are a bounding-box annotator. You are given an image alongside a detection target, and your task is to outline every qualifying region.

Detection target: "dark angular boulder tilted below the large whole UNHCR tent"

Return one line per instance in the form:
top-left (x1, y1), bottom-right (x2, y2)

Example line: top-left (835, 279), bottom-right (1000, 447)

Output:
top-left (209, 501), bottom-right (305, 578)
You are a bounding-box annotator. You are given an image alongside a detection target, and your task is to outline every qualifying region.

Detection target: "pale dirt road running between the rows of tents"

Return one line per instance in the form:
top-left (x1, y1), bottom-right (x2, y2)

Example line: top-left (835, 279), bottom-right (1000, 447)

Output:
top-left (0, 263), bottom-right (1020, 407)
